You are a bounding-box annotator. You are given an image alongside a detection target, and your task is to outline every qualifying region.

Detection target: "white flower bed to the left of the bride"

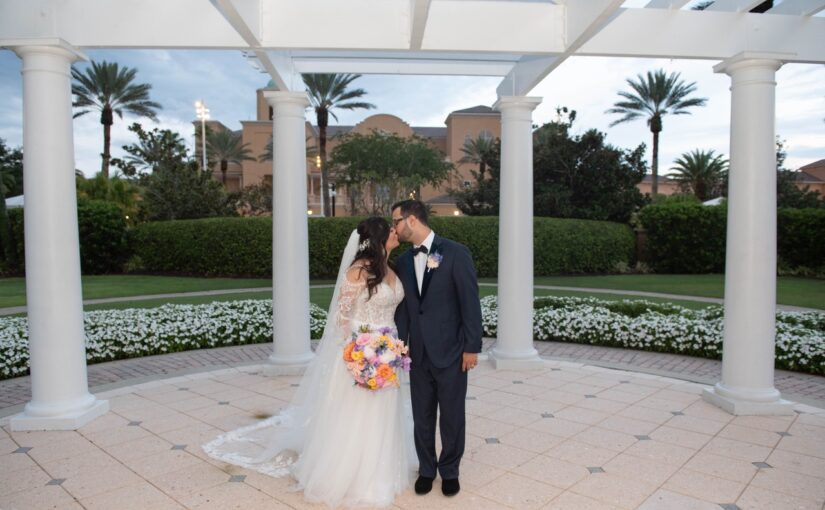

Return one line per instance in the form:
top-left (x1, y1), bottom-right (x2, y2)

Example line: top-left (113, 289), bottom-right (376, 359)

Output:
top-left (0, 300), bottom-right (327, 379)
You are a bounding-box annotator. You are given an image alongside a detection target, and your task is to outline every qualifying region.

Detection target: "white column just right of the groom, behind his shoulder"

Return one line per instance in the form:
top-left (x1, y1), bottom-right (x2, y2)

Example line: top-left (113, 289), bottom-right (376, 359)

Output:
top-left (490, 96), bottom-right (543, 369)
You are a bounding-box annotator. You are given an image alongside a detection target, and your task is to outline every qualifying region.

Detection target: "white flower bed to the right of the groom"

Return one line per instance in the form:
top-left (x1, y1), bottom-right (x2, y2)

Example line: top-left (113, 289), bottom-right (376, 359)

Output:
top-left (481, 296), bottom-right (825, 374)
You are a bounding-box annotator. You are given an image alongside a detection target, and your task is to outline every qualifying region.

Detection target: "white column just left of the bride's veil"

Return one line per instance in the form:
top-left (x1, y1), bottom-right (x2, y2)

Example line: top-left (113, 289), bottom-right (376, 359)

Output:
top-left (264, 90), bottom-right (314, 374)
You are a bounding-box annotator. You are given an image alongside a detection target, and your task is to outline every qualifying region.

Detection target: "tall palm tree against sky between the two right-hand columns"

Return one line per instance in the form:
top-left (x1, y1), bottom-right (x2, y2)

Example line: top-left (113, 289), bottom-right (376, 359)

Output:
top-left (607, 69), bottom-right (707, 197)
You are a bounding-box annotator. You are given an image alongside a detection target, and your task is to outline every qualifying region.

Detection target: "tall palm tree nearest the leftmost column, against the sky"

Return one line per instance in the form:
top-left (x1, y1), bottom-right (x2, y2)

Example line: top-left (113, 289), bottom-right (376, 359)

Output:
top-left (72, 60), bottom-right (161, 179)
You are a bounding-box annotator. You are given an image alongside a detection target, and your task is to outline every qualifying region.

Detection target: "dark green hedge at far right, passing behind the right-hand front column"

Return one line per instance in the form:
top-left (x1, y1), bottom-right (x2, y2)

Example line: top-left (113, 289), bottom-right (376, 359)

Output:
top-left (639, 203), bottom-right (825, 273)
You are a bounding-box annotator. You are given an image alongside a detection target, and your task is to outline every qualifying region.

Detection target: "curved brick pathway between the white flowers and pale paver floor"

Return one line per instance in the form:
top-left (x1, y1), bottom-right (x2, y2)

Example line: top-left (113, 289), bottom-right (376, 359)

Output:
top-left (0, 339), bottom-right (825, 416)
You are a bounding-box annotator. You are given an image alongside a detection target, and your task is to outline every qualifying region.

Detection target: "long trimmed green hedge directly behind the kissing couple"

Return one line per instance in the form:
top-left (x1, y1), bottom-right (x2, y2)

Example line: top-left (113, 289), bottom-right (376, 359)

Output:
top-left (130, 217), bottom-right (634, 279)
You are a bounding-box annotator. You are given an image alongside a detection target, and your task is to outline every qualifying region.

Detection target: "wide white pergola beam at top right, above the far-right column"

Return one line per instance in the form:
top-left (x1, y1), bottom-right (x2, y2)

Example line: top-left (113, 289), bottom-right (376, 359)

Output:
top-left (576, 9), bottom-right (825, 63)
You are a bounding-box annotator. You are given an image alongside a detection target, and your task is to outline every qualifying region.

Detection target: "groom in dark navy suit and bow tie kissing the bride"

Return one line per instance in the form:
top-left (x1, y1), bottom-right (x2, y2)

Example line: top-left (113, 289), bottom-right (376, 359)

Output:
top-left (392, 200), bottom-right (481, 496)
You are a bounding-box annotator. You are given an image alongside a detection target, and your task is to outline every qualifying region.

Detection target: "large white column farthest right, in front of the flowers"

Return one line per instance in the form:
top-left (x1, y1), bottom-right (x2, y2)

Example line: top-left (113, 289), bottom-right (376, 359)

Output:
top-left (704, 55), bottom-right (792, 415)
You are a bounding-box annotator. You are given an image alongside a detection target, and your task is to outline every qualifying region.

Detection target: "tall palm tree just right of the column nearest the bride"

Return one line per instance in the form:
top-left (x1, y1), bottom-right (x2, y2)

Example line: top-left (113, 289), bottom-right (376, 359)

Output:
top-left (303, 74), bottom-right (375, 216)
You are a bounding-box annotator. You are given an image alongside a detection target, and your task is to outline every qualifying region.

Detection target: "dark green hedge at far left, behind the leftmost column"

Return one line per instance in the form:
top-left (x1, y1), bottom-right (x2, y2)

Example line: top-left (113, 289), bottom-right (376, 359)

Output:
top-left (9, 199), bottom-right (128, 274)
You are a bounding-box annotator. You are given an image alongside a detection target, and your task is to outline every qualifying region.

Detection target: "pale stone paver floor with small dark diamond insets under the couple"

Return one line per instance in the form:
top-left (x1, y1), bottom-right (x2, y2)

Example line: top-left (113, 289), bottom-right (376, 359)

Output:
top-left (0, 361), bottom-right (825, 510)
